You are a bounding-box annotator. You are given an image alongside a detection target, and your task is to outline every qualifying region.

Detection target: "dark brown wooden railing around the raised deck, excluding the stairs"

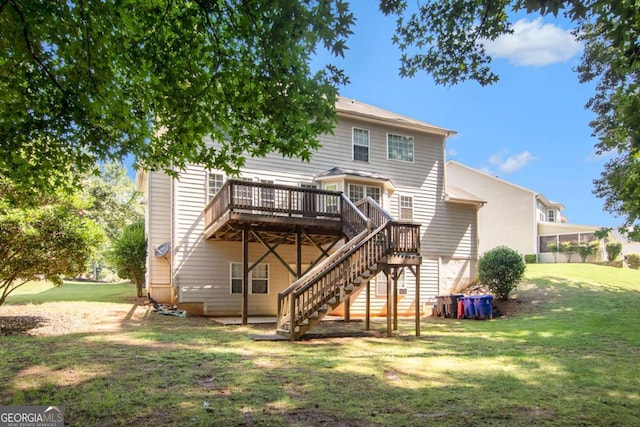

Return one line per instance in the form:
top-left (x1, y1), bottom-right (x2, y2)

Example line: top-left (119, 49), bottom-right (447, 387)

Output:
top-left (204, 180), bottom-right (344, 226)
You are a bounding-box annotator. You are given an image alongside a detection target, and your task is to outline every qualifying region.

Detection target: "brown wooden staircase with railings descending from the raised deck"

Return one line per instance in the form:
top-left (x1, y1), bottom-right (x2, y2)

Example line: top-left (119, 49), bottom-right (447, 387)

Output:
top-left (277, 198), bottom-right (419, 340)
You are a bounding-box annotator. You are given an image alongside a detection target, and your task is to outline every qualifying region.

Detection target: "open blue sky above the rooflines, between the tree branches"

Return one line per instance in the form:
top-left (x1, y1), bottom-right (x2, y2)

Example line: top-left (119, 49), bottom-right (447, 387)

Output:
top-left (313, 1), bottom-right (622, 226)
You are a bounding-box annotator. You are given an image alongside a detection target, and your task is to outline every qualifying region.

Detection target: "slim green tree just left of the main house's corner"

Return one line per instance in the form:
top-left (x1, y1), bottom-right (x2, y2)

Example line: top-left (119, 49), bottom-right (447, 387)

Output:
top-left (111, 221), bottom-right (147, 297)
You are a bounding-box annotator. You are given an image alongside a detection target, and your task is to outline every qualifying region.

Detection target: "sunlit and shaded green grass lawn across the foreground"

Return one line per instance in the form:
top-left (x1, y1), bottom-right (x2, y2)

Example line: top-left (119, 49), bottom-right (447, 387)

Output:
top-left (0, 264), bottom-right (640, 426)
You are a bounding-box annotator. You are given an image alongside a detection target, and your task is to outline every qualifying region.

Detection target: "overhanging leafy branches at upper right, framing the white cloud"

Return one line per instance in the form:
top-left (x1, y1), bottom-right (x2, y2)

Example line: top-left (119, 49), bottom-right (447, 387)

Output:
top-left (380, 0), bottom-right (640, 239)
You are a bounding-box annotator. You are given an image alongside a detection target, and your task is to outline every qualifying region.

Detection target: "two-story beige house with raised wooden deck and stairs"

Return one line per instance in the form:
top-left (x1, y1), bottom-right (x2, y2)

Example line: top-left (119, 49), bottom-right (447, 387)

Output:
top-left (137, 98), bottom-right (482, 336)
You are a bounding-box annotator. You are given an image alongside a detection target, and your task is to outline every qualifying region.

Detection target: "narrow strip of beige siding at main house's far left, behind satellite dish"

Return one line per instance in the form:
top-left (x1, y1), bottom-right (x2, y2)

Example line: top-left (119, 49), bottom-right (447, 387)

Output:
top-left (145, 172), bottom-right (173, 303)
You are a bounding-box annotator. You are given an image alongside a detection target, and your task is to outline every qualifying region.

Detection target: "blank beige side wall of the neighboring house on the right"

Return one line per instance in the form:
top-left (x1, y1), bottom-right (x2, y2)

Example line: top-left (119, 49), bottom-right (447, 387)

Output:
top-left (447, 163), bottom-right (537, 255)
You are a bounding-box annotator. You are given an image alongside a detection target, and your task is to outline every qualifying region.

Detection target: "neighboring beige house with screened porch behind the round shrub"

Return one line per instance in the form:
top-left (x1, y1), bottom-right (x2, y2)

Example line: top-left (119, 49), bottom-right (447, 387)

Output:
top-left (446, 160), bottom-right (601, 262)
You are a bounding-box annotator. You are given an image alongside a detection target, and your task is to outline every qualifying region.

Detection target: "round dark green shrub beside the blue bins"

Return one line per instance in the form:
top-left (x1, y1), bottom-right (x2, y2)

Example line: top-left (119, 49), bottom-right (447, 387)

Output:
top-left (478, 246), bottom-right (525, 300)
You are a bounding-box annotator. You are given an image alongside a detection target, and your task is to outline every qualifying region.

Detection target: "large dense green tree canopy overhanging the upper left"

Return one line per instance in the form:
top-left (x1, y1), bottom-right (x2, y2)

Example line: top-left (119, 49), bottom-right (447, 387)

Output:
top-left (0, 0), bottom-right (354, 191)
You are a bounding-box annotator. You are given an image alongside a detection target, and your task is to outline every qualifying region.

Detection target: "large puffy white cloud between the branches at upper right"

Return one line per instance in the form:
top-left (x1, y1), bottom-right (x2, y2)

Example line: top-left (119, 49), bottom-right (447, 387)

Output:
top-left (485, 18), bottom-right (582, 67)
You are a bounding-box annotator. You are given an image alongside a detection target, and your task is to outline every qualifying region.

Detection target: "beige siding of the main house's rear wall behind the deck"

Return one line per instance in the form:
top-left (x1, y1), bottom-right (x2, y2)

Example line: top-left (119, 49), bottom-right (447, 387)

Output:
top-left (165, 115), bottom-right (477, 315)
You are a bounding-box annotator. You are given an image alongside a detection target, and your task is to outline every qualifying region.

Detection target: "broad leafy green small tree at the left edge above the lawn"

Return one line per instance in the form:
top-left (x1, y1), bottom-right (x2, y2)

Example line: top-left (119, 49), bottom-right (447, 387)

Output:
top-left (0, 184), bottom-right (102, 305)
